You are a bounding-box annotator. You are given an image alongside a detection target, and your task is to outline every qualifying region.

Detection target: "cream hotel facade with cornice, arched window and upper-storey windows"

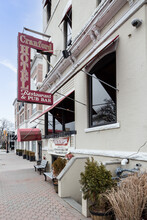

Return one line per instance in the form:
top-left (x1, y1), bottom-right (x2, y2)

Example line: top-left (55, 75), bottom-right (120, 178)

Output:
top-left (31, 0), bottom-right (147, 167)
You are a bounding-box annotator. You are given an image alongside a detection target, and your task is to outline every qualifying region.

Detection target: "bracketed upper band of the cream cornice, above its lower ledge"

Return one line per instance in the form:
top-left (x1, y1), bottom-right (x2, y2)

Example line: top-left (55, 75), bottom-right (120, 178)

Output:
top-left (40, 0), bottom-right (127, 91)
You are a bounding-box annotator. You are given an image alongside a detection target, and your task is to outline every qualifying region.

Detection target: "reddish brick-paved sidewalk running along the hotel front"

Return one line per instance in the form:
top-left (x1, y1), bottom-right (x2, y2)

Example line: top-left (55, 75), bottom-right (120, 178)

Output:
top-left (0, 150), bottom-right (91, 220)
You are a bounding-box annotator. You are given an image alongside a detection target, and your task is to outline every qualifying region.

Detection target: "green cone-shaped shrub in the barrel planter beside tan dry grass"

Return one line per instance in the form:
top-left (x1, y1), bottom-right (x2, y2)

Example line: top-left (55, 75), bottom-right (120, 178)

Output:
top-left (80, 158), bottom-right (115, 210)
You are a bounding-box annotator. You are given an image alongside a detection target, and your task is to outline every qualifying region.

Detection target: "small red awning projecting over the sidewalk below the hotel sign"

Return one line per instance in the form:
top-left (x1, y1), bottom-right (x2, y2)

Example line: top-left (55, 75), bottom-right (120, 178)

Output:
top-left (17, 128), bottom-right (41, 142)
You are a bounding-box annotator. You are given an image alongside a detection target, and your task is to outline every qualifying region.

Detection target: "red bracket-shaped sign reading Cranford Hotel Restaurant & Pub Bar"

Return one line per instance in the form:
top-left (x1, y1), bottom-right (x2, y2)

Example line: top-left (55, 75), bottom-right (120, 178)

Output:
top-left (17, 33), bottom-right (53, 105)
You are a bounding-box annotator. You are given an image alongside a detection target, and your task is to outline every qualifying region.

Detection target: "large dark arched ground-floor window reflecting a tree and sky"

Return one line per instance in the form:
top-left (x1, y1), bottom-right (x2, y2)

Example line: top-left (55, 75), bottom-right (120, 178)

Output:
top-left (88, 52), bottom-right (116, 127)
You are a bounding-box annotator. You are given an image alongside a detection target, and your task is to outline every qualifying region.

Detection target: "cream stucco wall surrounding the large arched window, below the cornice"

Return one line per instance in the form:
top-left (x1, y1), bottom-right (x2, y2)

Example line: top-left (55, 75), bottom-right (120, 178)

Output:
top-left (75, 7), bottom-right (147, 156)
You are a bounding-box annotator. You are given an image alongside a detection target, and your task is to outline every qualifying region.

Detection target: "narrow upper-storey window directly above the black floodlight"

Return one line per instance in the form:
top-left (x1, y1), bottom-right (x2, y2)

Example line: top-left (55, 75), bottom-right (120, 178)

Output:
top-left (64, 7), bottom-right (72, 48)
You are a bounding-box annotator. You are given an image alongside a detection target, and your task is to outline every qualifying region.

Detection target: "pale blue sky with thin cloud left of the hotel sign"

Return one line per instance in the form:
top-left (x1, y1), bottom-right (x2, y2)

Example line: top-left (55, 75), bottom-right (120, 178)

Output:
top-left (0, 0), bottom-right (42, 123)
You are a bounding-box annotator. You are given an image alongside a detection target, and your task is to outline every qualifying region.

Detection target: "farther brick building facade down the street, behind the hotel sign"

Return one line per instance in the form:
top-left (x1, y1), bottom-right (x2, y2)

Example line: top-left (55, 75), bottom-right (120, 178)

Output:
top-left (13, 51), bottom-right (43, 160)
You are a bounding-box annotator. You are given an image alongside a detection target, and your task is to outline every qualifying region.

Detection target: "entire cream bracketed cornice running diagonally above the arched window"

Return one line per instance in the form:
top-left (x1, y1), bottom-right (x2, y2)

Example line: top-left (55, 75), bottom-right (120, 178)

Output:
top-left (41, 0), bottom-right (146, 93)
